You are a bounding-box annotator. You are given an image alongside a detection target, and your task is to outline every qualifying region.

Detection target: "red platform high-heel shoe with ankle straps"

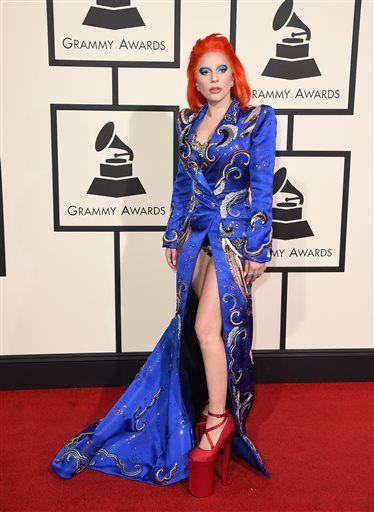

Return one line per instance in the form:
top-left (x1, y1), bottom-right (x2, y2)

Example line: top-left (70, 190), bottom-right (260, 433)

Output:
top-left (188, 410), bottom-right (235, 498)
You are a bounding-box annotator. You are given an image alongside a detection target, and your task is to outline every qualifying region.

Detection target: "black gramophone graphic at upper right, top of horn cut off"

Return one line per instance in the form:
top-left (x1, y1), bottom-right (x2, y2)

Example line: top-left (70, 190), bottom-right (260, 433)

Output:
top-left (262, 0), bottom-right (321, 80)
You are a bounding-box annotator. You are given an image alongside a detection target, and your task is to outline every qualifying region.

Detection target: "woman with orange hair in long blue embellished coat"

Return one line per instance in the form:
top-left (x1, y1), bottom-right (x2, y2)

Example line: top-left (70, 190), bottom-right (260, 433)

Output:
top-left (51, 34), bottom-right (276, 497)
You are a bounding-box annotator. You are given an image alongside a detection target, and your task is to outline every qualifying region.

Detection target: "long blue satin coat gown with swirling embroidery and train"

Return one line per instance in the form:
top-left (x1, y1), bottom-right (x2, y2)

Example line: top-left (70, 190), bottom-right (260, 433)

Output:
top-left (51, 96), bottom-right (277, 486)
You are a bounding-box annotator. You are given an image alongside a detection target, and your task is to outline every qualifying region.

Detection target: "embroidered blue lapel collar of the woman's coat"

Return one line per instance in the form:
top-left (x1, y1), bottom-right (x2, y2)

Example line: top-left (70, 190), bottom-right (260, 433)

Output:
top-left (182, 96), bottom-right (240, 199)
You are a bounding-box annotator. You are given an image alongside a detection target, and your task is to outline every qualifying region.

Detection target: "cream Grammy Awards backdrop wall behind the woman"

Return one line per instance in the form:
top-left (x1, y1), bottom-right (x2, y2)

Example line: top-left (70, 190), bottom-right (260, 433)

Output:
top-left (0, 0), bottom-right (373, 355)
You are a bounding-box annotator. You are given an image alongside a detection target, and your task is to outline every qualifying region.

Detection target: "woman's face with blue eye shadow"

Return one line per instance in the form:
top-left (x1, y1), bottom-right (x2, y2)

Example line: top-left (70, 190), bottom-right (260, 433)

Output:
top-left (196, 52), bottom-right (234, 102)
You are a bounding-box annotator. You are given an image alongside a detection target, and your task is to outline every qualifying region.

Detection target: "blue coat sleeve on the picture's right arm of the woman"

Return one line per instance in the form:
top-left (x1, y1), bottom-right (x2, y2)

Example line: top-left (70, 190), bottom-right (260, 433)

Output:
top-left (244, 105), bottom-right (277, 263)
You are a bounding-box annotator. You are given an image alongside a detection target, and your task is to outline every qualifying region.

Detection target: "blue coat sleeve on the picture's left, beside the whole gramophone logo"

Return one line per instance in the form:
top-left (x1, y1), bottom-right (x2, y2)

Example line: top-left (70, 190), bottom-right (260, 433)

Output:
top-left (162, 113), bottom-right (192, 249)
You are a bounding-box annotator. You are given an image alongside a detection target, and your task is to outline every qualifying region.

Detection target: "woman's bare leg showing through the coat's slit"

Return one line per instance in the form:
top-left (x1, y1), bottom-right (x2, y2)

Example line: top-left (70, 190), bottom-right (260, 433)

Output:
top-left (195, 258), bottom-right (227, 450)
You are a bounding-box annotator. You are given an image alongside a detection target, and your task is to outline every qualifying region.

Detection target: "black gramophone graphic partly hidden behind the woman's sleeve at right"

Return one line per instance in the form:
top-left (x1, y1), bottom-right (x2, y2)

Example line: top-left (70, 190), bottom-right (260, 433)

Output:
top-left (272, 167), bottom-right (314, 240)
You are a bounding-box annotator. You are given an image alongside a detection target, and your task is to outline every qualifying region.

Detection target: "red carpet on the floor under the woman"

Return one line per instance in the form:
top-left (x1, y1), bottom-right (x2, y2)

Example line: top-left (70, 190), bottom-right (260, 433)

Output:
top-left (0, 383), bottom-right (374, 512)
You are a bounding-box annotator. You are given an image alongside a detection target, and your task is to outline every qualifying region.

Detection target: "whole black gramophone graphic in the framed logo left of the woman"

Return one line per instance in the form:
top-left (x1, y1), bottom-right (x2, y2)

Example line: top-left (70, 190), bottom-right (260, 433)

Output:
top-left (87, 121), bottom-right (146, 197)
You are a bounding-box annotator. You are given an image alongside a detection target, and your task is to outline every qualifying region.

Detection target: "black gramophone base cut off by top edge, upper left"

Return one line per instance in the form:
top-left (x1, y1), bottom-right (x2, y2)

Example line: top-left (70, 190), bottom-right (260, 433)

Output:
top-left (82, 0), bottom-right (145, 30)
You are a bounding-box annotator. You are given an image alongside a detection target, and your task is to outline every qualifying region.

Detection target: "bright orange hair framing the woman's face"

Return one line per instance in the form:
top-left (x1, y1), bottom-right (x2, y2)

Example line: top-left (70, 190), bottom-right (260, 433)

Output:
top-left (187, 32), bottom-right (251, 112)
